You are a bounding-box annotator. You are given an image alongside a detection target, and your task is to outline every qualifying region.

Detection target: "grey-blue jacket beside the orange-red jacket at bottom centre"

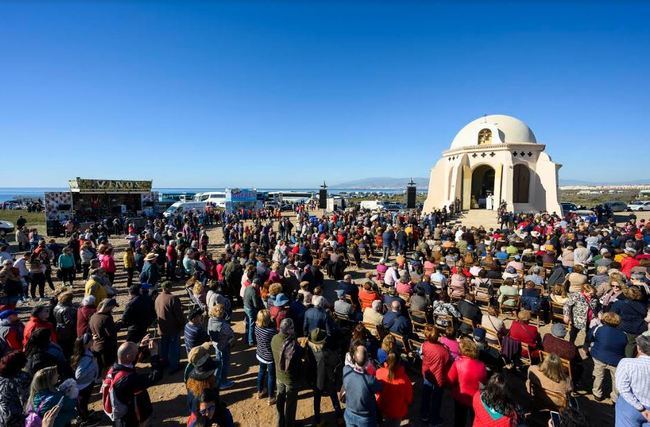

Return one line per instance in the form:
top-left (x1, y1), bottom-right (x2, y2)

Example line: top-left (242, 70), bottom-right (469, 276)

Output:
top-left (343, 366), bottom-right (381, 420)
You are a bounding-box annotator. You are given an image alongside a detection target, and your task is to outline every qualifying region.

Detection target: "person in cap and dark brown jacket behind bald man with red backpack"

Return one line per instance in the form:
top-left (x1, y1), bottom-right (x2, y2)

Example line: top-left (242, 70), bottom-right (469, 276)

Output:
top-left (88, 298), bottom-right (119, 372)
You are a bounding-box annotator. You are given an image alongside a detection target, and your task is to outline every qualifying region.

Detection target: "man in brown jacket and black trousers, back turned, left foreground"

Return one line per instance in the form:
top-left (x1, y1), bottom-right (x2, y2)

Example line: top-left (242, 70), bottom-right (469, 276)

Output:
top-left (155, 280), bottom-right (185, 375)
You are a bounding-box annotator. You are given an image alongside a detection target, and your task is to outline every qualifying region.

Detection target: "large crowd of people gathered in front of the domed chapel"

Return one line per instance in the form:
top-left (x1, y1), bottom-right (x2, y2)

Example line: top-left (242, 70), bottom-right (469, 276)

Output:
top-left (0, 205), bottom-right (650, 426)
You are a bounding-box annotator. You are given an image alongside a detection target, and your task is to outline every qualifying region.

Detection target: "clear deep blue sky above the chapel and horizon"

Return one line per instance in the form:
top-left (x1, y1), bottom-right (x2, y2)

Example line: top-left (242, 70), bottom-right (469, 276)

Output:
top-left (0, 1), bottom-right (650, 187)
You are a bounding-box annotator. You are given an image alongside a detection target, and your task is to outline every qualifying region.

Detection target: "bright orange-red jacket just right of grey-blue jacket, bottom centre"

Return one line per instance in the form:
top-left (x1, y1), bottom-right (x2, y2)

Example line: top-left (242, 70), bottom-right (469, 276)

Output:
top-left (376, 366), bottom-right (413, 420)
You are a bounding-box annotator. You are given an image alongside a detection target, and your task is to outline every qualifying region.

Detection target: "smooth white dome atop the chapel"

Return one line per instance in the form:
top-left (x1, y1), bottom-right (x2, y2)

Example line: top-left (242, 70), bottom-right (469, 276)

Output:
top-left (450, 114), bottom-right (537, 150)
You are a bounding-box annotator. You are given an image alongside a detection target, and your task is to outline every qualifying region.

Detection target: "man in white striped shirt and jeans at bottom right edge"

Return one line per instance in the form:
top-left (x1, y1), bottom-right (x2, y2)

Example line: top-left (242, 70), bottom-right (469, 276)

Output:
top-left (616, 335), bottom-right (650, 427)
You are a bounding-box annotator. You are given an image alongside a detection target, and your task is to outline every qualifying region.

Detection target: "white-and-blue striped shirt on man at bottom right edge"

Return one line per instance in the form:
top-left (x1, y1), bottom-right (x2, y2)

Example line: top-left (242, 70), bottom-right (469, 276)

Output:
top-left (616, 355), bottom-right (650, 411)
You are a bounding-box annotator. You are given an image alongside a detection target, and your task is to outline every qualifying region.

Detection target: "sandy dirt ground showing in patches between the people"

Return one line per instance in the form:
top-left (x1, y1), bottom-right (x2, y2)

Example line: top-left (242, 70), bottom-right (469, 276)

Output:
top-left (11, 213), bottom-right (648, 426)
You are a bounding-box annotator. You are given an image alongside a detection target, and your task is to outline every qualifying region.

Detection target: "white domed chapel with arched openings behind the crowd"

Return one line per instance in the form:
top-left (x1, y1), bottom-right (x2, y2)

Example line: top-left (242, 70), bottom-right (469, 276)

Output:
top-left (424, 114), bottom-right (562, 214)
